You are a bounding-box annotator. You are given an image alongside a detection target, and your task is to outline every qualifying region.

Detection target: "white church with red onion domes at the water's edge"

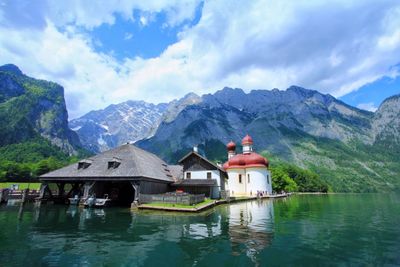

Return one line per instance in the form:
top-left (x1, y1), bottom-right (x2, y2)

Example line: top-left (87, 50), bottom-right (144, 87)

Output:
top-left (223, 135), bottom-right (272, 197)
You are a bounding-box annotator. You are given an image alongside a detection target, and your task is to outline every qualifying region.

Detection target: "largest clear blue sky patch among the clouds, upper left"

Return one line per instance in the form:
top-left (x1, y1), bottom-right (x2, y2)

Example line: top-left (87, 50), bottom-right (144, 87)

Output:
top-left (88, 4), bottom-right (202, 61)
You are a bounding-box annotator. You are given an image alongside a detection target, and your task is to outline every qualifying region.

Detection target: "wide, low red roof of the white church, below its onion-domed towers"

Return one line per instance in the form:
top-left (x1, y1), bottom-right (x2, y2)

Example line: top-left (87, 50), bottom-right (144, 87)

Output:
top-left (223, 152), bottom-right (269, 170)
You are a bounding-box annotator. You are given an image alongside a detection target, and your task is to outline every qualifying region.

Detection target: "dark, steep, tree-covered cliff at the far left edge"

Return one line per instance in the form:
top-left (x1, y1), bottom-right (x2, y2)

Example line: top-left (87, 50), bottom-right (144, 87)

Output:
top-left (0, 64), bottom-right (81, 155)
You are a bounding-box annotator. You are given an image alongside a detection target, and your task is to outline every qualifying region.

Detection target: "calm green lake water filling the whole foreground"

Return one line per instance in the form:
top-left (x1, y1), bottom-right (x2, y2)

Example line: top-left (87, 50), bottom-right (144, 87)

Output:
top-left (0, 194), bottom-right (400, 266)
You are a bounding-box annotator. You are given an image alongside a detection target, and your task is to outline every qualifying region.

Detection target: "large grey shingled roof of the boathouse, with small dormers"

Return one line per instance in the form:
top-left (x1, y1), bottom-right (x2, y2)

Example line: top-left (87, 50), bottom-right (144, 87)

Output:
top-left (39, 144), bottom-right (174, 182)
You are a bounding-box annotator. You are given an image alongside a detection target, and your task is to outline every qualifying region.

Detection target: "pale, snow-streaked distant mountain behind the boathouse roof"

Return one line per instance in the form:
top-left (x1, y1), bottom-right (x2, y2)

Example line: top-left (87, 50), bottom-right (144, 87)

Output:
top-left (69, 93), bottom-right (201, 152)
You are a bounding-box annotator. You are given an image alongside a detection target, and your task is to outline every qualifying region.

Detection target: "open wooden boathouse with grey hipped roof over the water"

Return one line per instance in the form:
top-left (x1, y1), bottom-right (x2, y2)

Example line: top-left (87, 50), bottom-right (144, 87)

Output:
top-left (39, 144), bottom-right (182, 206)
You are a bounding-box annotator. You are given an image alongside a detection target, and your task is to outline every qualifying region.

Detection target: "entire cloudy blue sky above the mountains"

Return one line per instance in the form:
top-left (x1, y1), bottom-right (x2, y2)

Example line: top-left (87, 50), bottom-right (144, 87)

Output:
top-left (0, 0), bottom-right (400, 118)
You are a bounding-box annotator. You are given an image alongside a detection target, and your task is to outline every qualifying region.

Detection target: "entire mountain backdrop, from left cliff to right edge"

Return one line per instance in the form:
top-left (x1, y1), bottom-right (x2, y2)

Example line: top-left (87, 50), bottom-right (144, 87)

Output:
top-left (0, 65), bottom-right (400, 192)
